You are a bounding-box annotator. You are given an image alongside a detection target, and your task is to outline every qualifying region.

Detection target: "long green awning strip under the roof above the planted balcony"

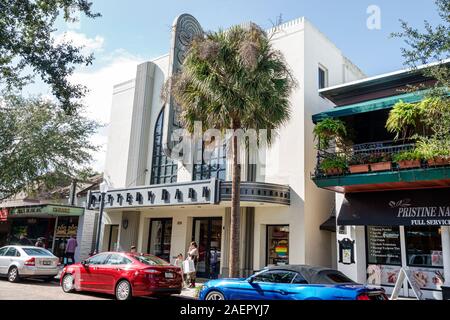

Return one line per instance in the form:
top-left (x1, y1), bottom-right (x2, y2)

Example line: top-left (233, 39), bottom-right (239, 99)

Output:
top-left (312, 90), bottom-right (427, 123)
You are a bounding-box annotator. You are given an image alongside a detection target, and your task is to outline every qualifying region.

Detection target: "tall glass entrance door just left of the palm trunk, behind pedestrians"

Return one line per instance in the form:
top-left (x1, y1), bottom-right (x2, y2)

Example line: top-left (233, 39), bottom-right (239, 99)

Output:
top-left (192, 218), bottom-right (222, 279)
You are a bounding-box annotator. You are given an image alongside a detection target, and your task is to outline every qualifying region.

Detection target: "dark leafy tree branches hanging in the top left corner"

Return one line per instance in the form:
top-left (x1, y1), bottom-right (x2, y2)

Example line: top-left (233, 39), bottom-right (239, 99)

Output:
top-left (0, 0), bottom-right (100, 112)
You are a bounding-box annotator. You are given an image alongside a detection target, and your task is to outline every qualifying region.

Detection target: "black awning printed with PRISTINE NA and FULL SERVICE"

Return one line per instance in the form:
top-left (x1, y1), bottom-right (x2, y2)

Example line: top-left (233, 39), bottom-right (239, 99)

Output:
top-left (337, 188), bottom-right (450, 226)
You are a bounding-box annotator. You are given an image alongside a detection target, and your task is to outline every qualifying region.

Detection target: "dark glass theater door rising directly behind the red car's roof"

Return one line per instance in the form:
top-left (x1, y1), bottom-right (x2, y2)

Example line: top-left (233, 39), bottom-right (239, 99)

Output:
top-left (147, 218), bottom-right (172, 262)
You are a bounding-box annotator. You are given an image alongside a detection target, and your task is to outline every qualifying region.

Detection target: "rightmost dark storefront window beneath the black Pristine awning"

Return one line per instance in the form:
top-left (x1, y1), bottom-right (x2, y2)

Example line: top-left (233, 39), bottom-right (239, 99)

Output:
top-left (405, 226), bottom-right (443, 267)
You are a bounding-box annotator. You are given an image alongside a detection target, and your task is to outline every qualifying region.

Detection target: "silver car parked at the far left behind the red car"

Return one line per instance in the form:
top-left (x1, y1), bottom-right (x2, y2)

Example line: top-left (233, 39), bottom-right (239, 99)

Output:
top-left (0, 246), bottom-right (59, 282)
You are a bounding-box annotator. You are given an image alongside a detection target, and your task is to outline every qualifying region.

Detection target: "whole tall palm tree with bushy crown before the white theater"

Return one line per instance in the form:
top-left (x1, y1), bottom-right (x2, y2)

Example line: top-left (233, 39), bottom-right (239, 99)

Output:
top-left (170, 24), bottom-right (295, 277)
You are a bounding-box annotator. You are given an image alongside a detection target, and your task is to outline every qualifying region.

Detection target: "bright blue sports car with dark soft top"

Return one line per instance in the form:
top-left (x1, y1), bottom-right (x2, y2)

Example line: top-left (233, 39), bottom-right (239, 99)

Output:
top-left (199, 265), bottom-right (388, 300)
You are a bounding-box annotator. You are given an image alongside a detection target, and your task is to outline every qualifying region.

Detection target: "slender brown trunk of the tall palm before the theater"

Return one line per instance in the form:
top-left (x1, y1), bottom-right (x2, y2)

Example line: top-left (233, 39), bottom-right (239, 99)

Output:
top-left (229, 124), bottom-right (241, 277)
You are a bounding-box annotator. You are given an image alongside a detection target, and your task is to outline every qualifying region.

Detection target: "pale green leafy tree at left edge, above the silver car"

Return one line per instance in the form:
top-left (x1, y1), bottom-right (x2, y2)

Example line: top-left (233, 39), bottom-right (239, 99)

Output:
top-left (0, 95), bottom-right (98, 200)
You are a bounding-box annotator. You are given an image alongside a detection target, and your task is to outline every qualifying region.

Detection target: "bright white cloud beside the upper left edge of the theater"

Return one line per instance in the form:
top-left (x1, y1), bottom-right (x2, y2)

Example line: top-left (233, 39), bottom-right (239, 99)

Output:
top-left (71, 50), bottom-right (144, 172)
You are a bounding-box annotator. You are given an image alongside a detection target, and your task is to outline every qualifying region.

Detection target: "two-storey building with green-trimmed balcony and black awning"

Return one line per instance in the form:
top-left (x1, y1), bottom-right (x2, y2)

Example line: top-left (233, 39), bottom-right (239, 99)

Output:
top-left (312, 66), bottom-right (450, 299)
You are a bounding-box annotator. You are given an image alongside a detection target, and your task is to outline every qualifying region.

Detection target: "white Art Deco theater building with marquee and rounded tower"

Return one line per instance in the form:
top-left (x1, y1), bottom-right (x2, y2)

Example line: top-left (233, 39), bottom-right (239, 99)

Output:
top-left (89, 14), bottom-right (364, 278)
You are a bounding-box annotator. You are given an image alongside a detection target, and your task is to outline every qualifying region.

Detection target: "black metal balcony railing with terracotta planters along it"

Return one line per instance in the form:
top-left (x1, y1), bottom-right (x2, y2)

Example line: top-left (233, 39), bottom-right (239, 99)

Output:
top-left (312, 141), bottom-right (449, 179)
